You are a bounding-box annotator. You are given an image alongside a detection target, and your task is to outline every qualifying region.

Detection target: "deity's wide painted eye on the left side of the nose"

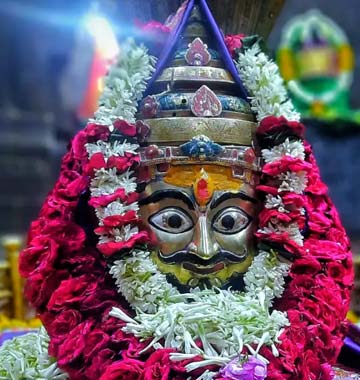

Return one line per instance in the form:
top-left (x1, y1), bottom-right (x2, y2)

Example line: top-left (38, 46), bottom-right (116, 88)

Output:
top-left (149, 207), bottom-right (194, 234)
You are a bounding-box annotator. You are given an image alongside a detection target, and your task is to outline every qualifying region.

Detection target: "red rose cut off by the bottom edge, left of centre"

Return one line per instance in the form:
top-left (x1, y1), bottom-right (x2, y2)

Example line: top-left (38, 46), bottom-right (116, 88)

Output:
top-left (100, 359), bottom-right (144, 380)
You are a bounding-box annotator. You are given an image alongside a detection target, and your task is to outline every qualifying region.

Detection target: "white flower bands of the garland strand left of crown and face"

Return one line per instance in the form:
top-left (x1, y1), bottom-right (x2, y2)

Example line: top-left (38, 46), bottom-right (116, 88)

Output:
top-left (85, 40), bottom-right (156, 244)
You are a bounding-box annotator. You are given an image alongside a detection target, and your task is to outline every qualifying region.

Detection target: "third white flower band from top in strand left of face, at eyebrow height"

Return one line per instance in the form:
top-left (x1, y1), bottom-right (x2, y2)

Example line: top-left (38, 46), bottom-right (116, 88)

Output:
top-left (90, 168), bottom-right (137, 197)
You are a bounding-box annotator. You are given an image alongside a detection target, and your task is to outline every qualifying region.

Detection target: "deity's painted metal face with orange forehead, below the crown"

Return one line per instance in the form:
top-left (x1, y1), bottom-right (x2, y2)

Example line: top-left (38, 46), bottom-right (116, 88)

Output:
top-left (140, 165), bottom-right (257, 290)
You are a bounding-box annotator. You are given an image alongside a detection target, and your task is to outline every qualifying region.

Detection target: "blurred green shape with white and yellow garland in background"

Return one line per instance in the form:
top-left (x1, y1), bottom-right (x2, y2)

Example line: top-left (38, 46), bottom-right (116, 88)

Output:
top-left (277, 10), bottom-right (360, 123)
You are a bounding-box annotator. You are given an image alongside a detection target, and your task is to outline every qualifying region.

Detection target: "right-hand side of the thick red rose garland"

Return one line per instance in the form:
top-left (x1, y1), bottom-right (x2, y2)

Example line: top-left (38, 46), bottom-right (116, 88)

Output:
top-left (258, 117), bottom-right (353, 380)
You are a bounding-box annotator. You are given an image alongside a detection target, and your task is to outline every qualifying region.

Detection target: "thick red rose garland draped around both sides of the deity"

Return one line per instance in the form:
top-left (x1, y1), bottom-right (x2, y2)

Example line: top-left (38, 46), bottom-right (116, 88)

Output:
top-left (20, 117), bottom-right (352, 380)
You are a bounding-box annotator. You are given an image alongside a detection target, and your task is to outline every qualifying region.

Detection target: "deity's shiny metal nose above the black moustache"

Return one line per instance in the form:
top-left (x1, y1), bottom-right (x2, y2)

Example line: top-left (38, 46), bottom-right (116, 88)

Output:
top-left (188, 215), bottom-right (220, 260)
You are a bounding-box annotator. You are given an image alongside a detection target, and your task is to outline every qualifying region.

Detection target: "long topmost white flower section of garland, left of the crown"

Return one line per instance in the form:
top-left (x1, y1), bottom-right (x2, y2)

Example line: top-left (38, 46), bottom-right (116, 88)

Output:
top-left (95, 40), bottom-right (156, 127)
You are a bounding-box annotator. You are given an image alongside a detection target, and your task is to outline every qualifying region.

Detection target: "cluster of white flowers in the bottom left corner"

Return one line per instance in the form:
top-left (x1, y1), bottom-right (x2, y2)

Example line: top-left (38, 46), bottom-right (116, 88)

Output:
top-left (0, 328), bottom-right (68, 380)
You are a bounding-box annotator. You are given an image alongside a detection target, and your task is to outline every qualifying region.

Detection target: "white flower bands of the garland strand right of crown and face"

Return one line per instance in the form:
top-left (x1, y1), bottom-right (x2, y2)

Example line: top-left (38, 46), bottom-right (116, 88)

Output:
top-left (235, 44), bottom-right (307, 246)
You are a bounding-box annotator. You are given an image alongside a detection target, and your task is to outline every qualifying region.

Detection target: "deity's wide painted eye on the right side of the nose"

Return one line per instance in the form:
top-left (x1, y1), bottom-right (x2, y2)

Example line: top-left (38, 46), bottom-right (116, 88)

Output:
top-left (213, 207), bottom-right (251, 234)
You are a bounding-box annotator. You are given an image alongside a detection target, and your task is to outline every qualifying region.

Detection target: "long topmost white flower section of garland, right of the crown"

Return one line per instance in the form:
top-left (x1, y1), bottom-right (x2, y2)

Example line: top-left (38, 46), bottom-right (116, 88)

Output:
top-left (235, 44), bottom-right (300, 121)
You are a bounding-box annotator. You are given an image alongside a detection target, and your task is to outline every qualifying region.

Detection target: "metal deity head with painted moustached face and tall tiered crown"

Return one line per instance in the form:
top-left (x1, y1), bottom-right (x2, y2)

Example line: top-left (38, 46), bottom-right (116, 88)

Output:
top-left (138, 3), bottom-right (258, 291)
